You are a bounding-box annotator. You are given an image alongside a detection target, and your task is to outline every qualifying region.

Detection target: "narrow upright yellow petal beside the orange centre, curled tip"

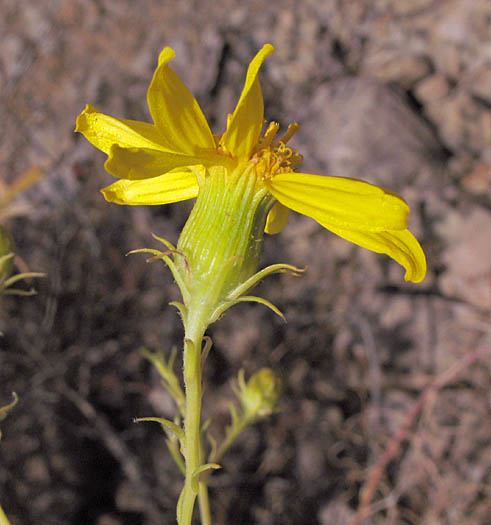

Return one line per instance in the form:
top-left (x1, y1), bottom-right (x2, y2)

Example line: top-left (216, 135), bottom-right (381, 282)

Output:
top-left (221, 44), bottom-right (274, 158)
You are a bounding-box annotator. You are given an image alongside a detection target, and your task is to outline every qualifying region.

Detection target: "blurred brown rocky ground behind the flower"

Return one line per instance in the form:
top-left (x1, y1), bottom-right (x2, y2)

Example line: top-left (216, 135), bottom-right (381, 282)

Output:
top-left (0, 0), bottom-right (491, 525)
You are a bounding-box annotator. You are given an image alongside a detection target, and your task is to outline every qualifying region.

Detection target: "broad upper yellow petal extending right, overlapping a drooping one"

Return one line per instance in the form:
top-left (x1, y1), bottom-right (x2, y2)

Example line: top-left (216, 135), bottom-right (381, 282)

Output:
top-left (268, 172), bottom-right (409, 231)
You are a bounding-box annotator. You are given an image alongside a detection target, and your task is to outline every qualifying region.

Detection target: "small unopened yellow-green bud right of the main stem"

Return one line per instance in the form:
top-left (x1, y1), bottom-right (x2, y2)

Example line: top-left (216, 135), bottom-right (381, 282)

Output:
top-left (238, 368), bottom-right (281, 417)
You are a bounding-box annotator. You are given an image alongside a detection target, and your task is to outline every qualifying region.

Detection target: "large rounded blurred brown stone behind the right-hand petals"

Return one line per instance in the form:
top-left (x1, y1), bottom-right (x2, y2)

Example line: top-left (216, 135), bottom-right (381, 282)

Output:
top-left (302, 77), bottom-right (442, 186)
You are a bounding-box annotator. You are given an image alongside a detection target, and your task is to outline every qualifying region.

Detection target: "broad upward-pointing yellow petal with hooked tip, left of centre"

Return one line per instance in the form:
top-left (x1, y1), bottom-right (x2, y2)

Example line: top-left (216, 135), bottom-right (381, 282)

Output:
top-left (147, 47), bottom-right (216, 154)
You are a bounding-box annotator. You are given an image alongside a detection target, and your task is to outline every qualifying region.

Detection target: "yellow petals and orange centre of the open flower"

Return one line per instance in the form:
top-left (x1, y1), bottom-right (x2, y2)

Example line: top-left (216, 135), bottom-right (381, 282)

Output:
top-left (76, 44), bottom-right (426, 282)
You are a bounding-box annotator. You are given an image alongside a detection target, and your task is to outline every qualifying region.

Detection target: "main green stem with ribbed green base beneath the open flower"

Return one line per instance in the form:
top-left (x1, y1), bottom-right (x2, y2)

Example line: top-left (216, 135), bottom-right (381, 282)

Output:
top-left (175, 163), bottom-right (274, 525)
